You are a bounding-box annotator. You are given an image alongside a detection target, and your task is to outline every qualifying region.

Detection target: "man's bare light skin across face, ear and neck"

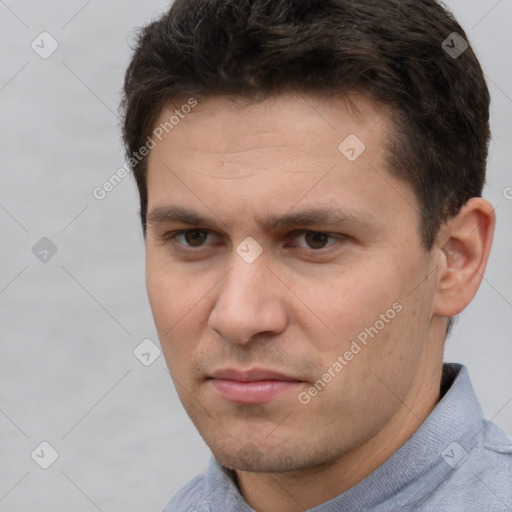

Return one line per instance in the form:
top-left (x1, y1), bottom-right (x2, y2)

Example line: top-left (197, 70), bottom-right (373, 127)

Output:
top-left (146, 93), bottom-right (495, 512)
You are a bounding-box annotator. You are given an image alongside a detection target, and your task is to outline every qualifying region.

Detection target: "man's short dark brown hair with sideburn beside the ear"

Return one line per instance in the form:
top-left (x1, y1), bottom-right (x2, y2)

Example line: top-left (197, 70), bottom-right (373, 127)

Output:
top-left (121, 0), bottom-right (490, 249)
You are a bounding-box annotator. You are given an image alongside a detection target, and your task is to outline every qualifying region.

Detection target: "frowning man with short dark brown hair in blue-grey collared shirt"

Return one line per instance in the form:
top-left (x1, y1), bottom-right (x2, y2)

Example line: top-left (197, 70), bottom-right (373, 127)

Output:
top-left (123, 0), bottom-right (512, 512)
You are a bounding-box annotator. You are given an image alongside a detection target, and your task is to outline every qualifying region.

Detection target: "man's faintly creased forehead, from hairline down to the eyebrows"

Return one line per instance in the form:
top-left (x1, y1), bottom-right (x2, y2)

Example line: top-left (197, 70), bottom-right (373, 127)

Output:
top-left (147, 93), bottom-right (415, 231)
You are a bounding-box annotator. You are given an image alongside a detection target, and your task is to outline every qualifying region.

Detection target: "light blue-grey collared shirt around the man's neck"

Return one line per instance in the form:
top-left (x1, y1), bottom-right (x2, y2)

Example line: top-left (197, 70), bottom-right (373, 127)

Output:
top-left (163, 363), bottom-right (512, 512)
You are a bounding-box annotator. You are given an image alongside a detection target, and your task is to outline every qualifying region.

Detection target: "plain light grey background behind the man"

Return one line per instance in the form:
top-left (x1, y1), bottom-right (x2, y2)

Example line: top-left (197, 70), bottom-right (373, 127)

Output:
top-left (0, 0), bottom-right (512, 512)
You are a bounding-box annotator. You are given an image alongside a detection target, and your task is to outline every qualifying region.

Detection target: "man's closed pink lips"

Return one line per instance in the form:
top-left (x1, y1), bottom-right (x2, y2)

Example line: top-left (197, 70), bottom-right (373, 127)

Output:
top-left (208, 368), bottom-right (303, 404)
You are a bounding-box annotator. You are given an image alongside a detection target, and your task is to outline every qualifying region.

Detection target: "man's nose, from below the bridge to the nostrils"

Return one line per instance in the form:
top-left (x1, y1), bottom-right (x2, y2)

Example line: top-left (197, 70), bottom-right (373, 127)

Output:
top-left (208, 254), bottom-right (288, 344)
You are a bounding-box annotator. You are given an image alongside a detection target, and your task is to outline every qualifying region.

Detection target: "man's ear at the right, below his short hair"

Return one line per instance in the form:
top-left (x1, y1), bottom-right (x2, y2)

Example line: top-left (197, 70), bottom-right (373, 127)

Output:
top-left (434, 197), bottom-right (496, 317)
